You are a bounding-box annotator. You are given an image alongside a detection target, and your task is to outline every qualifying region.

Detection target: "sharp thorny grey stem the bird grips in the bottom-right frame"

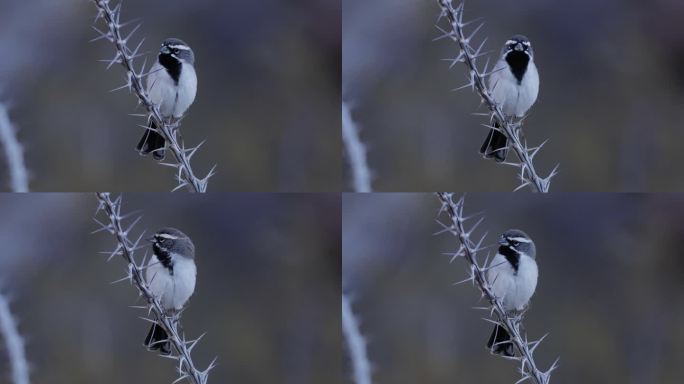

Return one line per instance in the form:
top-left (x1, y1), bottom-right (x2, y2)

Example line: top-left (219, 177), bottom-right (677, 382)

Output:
top-left (437, 192), bottom-right (558, 384)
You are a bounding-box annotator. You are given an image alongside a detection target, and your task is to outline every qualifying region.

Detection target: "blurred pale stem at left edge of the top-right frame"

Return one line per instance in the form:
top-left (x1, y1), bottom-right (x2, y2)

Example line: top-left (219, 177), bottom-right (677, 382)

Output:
top-left (342, 102), bottom-right (371, 192)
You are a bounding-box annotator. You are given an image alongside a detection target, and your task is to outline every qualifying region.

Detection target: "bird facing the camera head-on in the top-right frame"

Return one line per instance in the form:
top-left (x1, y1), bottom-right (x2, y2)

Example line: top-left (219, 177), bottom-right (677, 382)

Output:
top-left (480, 35), bottom-right (539, 162)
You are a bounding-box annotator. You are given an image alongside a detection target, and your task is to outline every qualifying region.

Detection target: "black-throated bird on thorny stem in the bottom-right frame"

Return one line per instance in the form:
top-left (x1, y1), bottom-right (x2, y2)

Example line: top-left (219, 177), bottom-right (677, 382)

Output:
top-left (486, 229), bottom-right (539, 357)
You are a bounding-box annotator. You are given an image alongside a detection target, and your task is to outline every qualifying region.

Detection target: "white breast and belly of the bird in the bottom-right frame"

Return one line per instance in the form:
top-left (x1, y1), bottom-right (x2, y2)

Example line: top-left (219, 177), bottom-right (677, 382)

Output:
top-left (487, 254), bottom-right (539, 311)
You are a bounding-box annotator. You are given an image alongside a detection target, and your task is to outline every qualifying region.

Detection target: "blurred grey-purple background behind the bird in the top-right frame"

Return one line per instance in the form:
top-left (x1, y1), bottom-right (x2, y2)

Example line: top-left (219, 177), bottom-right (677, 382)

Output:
top-left (342, 0), bottom-right (684, 192)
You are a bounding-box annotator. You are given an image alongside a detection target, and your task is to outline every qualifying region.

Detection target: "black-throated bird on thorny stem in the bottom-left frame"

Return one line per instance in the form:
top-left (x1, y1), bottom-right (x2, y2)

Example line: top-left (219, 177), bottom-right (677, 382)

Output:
top-left (145, 228), bottom-right (197, 355)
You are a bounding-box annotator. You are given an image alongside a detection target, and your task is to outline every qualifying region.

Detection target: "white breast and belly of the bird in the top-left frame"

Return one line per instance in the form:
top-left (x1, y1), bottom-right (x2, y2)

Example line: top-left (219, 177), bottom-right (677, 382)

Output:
top-left (147, 63), bottom-right (197, 118)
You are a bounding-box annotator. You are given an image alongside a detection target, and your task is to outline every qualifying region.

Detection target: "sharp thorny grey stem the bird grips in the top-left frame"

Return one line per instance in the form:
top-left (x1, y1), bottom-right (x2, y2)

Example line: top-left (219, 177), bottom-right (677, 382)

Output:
top-left (93, 0), bottom-right (216, 192)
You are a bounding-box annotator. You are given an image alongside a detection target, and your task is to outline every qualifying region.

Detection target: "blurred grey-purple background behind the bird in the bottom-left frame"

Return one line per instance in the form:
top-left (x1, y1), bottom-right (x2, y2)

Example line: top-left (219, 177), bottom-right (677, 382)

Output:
top-left (0, 194), bottom-right (344, 384)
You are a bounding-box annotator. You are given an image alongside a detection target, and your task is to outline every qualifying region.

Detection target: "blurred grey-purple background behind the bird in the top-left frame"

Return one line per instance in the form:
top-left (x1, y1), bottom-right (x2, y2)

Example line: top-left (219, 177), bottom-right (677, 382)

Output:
top-left (0, 0), bottom-right (342, 192)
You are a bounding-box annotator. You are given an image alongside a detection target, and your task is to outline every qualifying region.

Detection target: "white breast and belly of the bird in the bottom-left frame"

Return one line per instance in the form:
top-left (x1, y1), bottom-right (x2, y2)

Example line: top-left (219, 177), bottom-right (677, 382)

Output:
top-left (145, 255), bottom-right (197, 310)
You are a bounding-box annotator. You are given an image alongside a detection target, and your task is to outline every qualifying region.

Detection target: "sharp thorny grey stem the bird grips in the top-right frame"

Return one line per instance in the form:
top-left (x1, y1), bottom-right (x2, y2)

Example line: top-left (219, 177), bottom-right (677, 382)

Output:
top-left (437, 0), bottom-right (558, 192)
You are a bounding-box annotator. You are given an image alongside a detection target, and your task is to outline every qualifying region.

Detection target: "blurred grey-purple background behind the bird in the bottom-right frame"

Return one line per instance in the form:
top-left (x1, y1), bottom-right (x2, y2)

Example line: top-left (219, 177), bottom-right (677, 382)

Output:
top-left (342, 193), bottom-right (684, 384)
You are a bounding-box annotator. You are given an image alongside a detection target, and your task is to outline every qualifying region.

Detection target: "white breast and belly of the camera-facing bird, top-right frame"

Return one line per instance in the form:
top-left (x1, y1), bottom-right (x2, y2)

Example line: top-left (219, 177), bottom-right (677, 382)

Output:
top-left (489, 59), bottom-right (539, 117)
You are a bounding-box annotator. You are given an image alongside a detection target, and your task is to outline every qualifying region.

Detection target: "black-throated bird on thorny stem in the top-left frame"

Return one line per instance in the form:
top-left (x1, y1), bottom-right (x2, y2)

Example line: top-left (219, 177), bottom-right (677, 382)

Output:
top-left (136, 38), bottom-right (197, 160)
